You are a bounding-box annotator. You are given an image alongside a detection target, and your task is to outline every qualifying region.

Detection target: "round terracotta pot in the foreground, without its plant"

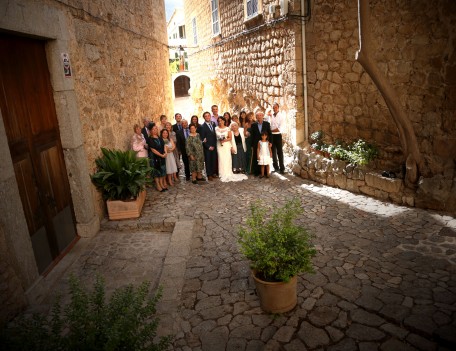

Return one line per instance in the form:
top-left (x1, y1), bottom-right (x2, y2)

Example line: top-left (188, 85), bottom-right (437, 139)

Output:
top-left (252, 273), bottom-right (297, 313)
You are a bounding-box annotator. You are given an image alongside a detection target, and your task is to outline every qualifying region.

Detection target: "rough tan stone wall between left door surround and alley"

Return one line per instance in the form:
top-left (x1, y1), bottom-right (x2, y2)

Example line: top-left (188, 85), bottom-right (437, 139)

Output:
top-left (60, 0), bottom-right (171, 167)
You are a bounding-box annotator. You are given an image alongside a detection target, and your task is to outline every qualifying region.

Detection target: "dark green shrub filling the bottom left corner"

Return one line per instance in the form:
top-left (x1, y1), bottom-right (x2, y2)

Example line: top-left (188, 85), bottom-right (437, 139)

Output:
top-left (0, 277), bottom-right (172, 351)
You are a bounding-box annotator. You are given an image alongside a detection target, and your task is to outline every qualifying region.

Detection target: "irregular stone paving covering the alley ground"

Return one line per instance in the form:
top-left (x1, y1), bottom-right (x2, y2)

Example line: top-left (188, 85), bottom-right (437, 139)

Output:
top-left (32, 174), bottom-right (456, 351)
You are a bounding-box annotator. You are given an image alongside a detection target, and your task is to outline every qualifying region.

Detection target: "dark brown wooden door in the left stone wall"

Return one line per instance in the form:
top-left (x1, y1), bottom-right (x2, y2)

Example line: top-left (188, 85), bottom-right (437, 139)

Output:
top-left (0, 33), bottom-right (76, 273)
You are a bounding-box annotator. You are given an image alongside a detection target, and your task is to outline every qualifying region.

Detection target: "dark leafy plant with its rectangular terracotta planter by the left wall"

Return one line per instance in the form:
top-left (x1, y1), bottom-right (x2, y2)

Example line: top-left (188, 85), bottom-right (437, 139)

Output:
top-left (91, 148), bottom-right (152, 220)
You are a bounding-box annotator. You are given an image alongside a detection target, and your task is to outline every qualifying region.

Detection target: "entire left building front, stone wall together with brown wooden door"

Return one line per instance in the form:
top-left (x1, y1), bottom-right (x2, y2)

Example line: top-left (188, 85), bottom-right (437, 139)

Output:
top-left (0, 0), bottom-right (172, 322)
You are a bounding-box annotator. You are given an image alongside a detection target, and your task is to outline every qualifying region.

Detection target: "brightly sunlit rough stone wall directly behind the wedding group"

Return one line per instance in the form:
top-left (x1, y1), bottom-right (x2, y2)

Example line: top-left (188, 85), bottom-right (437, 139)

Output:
top-left (184, 0), bottom-right (304, 142)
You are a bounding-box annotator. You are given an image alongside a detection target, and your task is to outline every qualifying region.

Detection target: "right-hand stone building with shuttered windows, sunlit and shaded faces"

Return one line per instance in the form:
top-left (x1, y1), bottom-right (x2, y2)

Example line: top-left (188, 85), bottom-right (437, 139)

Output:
top-left (184, 0), bottom-right (456, 212)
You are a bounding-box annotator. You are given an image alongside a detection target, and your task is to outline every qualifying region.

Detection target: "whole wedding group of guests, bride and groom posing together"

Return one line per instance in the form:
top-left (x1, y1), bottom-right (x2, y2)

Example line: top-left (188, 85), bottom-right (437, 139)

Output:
top-left (131, 103), bottom-right (285, 192)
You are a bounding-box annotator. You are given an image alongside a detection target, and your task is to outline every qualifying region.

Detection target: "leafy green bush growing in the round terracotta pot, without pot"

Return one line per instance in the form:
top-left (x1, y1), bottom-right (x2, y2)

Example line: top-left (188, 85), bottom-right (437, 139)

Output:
top-left (239, 199), bottom-right (316, 281)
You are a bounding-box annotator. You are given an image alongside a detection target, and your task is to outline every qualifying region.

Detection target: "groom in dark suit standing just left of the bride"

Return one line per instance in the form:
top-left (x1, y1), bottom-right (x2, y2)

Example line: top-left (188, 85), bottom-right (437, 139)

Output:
top-left (199, 112), bottom-right (217, 180)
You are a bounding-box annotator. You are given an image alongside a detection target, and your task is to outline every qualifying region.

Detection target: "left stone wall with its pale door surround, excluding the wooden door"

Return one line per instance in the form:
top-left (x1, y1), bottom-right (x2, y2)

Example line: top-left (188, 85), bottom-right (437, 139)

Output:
top-left (0, 0), bottom-right (172, 321)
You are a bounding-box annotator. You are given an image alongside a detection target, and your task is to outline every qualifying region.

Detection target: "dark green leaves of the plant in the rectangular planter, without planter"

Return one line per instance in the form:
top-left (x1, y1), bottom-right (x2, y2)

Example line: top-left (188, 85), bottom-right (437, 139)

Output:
top-left (91, 148), bottom-right (152, 200)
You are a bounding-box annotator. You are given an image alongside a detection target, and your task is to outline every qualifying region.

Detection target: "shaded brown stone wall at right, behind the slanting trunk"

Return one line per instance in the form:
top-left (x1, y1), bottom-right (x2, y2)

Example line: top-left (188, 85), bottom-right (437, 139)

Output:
top-left (306, 0), bottom-right (456, 177)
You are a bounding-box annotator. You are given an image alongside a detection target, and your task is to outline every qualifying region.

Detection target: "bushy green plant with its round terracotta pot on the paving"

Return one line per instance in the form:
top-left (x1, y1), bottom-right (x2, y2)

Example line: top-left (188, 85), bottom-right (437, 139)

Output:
top-left (239, 198), bottom-right (316, 313)
